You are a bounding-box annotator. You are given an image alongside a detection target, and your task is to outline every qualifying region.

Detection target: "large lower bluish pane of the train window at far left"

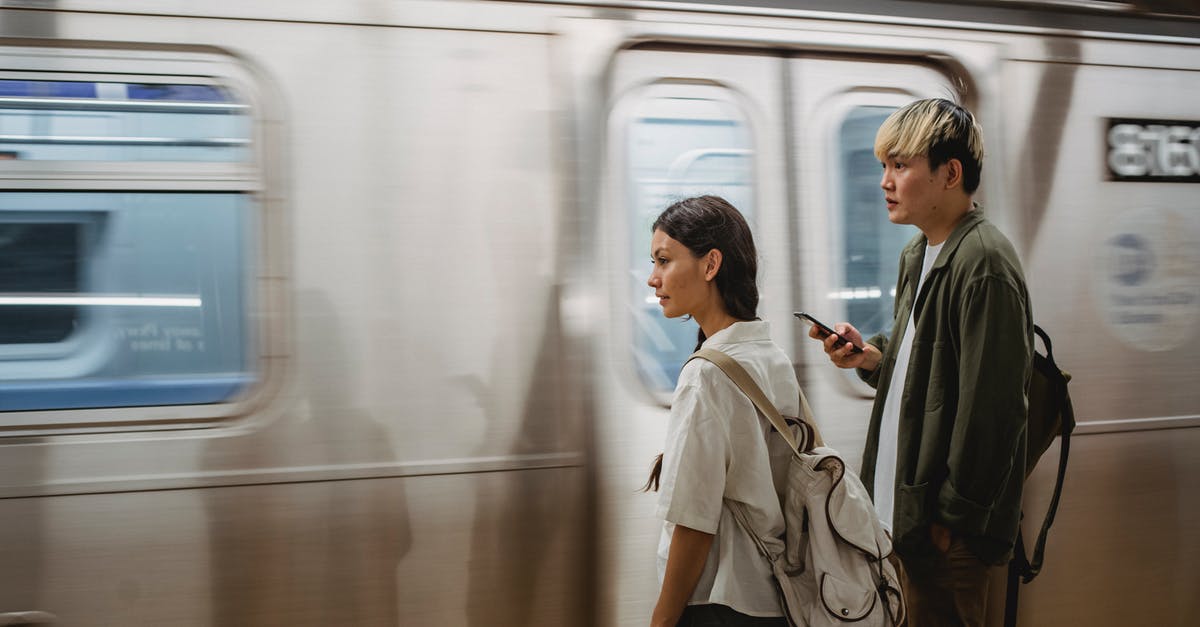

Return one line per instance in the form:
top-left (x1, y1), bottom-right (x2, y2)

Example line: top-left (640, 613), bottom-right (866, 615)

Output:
top-left (0, 192), bottom-right (256, 411)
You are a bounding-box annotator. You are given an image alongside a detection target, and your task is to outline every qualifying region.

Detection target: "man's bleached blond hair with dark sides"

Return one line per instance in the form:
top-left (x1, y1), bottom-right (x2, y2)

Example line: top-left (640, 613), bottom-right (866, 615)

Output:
top-left (875, 98), bottom-right (983, 193)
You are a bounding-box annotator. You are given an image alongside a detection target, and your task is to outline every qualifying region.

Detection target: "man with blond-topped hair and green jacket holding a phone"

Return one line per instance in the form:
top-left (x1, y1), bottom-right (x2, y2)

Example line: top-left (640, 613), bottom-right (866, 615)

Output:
top-left (809, 98), bottom-right (1033, 627)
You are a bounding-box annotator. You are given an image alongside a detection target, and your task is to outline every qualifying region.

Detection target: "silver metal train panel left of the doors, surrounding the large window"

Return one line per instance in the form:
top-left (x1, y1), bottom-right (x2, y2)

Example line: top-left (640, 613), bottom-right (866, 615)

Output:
top-left (0, 3), bottom-right (593, 625)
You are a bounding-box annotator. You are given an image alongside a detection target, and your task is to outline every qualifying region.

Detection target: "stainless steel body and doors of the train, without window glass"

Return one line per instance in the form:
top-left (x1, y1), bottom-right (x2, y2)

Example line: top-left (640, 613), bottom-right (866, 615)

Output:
top-left (0, 0), bottom-right (1200, 626)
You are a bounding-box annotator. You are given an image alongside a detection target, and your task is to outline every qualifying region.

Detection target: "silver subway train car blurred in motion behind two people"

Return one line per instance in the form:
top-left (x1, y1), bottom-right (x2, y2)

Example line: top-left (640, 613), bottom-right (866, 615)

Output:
top-left (0, 0), bottom-right (1200, 627)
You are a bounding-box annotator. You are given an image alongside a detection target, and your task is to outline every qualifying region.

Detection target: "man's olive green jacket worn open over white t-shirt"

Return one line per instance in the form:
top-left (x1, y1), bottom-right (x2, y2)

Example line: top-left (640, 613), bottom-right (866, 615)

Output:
top-left (858, 208), bottom-right (1033, 565)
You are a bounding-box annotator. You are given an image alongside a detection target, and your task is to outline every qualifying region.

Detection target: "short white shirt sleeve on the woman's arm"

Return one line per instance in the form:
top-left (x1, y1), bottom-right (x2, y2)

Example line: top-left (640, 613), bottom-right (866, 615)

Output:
top-left (658, 366), bottom-right (731, 533)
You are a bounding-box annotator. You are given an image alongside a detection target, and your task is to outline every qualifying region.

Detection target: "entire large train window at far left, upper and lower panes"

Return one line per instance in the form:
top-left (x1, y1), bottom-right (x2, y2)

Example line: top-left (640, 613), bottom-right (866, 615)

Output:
top-left (0, 48), bottom-right (262, 431)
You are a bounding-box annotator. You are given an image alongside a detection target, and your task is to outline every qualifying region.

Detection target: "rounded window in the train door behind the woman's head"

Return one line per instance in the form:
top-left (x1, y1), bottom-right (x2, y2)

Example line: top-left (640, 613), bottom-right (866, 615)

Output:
top-left (625, 88), bottom-right (754, 393)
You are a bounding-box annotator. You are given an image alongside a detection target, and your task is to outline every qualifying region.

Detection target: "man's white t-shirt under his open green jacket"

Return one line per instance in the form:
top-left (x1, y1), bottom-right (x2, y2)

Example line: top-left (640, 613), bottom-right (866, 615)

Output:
top-left (875, 241), bottom-right (946, 526)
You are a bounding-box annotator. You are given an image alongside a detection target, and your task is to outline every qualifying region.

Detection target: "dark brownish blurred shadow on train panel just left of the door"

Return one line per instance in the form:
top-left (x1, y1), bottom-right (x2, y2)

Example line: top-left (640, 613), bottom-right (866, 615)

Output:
top-left (467, 285), bottom-right (593, 627)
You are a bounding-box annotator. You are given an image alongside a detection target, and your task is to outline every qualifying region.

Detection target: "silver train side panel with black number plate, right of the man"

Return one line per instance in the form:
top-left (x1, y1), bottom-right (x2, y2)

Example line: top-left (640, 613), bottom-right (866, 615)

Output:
top-left (1004, 52), bottom-right (1200, 625)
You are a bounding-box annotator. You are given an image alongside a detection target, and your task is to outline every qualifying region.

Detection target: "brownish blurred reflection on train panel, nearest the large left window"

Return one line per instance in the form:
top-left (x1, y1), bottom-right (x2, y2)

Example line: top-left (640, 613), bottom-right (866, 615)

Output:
top-left (205, 292), bottom-right (412, 627)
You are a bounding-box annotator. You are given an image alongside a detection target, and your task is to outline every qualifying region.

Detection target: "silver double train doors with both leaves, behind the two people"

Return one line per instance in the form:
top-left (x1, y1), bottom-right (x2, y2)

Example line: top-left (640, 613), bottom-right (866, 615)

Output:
top-left (596, 46), bottom-right (953, 625)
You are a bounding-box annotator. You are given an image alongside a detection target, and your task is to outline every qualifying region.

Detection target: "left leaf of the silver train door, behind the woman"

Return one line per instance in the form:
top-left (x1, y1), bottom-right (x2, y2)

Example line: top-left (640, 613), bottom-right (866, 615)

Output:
top-left (596, 48), bottom-right (792, 625)
